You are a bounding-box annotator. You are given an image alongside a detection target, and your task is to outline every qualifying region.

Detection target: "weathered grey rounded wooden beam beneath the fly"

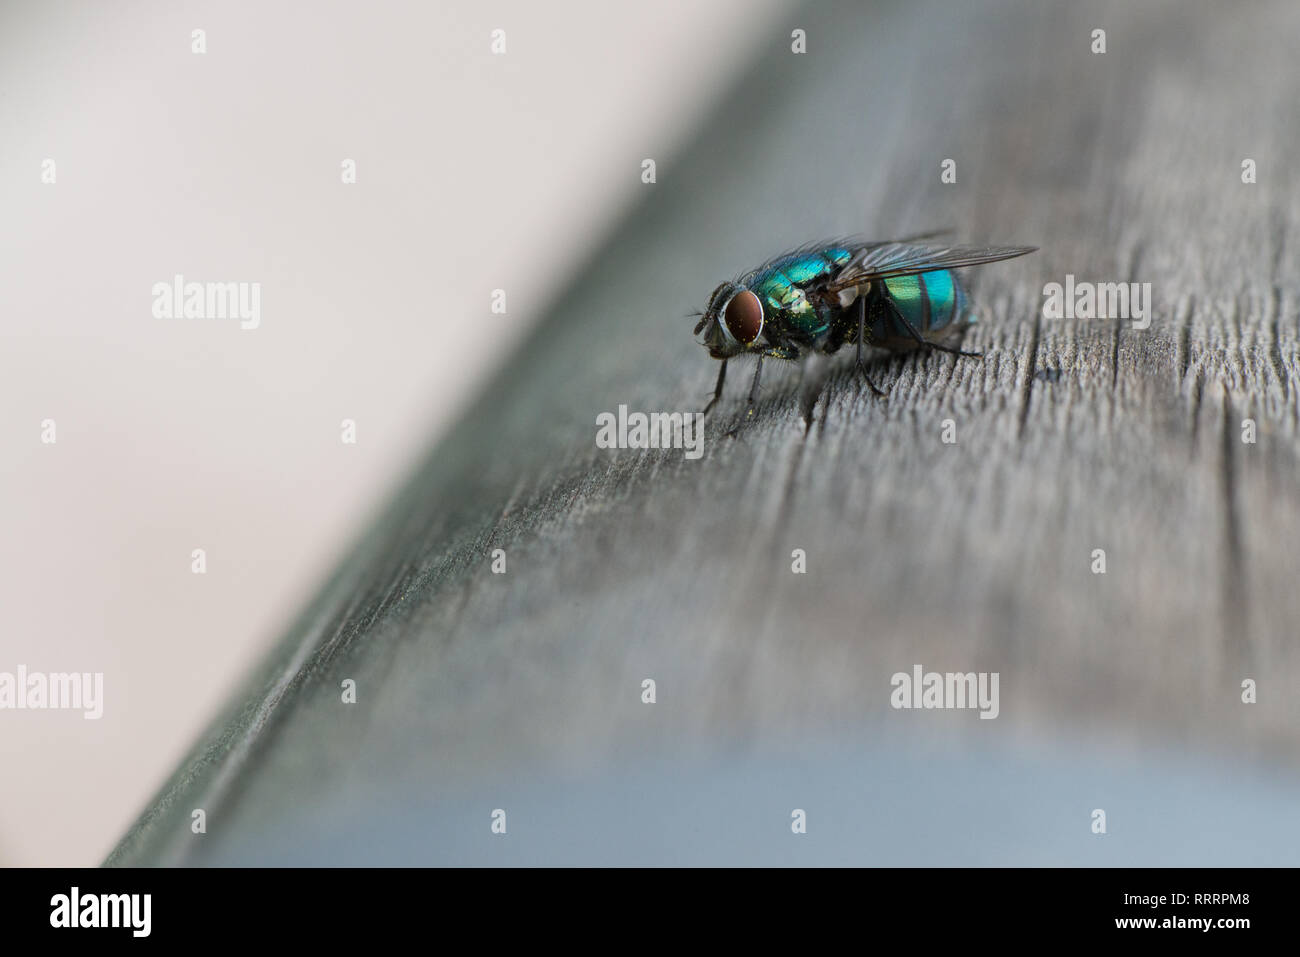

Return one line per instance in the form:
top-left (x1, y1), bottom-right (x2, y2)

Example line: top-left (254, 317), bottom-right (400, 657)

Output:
top-left (111, 3), bottom-right (1300, 863)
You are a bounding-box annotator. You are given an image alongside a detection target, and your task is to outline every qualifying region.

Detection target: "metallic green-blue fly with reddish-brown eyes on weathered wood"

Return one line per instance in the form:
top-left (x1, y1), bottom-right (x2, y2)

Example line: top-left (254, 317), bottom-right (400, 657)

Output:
top-left (696, 233), bottom-right (1037, 421)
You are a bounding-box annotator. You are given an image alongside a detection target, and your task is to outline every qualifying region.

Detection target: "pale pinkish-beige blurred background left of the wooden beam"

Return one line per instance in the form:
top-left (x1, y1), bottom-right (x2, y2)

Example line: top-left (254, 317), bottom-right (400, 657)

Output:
top-left (0, 0), bottom-right (788, 865)
